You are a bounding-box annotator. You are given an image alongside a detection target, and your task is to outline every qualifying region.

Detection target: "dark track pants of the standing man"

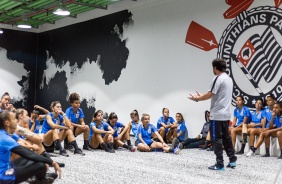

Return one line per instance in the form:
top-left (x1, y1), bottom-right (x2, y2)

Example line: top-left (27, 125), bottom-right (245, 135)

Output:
top-left (210, 120), bottom-right (237, 167)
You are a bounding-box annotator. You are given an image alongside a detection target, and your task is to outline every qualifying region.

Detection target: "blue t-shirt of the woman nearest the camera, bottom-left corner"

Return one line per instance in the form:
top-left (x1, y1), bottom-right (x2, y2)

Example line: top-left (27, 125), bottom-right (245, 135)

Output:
top-left (0, 129), bottom-right (19, 183)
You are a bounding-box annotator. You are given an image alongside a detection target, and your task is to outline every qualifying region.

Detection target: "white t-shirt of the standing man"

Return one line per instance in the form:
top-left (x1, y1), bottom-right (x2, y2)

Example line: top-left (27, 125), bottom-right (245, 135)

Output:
top-left (209, 72), bottom-right (233, 121)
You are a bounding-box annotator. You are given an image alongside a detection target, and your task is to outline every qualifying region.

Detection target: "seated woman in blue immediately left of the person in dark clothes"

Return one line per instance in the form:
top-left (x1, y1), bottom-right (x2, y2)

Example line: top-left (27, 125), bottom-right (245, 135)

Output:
top-left (170, 112), bottom-right (187, 148)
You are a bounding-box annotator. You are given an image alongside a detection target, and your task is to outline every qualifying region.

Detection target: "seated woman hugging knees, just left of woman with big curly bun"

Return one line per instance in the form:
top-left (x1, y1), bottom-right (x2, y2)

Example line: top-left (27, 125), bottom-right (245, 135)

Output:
top-left (42, 101), bottom-right (85, 157)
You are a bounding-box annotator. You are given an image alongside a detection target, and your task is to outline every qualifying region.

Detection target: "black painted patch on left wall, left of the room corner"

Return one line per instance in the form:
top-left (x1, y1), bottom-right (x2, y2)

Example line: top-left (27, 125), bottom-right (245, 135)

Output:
top-left (0, 29), bottom-right (37, 109)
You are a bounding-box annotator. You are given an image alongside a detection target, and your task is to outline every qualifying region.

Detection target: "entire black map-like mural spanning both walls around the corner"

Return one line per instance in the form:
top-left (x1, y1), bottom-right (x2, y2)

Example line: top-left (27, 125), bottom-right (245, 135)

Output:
top-left (0, 10), bottom-right (133, 123)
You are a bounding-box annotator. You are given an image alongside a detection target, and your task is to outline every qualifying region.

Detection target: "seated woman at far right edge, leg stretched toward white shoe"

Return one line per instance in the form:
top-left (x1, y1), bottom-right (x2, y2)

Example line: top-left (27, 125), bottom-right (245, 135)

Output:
top-left (246, 98), bottom-right (282, 157)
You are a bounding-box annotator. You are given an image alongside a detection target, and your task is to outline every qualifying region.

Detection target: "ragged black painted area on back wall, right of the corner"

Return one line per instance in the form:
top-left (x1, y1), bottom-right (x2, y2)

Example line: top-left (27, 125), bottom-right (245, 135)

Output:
top-left (36, 10), bottom-right (133, 124)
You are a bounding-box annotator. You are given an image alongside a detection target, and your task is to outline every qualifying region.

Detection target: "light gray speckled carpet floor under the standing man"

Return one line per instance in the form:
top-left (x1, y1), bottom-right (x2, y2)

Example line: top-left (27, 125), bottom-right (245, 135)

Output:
top-left (41, 136), bottom-right (282, 184)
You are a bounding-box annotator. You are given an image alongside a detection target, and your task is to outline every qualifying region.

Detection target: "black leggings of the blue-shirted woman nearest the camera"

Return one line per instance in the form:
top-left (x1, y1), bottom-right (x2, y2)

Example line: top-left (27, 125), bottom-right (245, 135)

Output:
top-left (12, 157), bottom-right (47, 183)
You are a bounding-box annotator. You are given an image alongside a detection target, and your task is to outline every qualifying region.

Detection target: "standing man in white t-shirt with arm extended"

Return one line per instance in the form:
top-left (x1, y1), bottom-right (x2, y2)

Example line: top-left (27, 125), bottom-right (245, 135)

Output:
top-left (188, 59), bottom-right (237, 170)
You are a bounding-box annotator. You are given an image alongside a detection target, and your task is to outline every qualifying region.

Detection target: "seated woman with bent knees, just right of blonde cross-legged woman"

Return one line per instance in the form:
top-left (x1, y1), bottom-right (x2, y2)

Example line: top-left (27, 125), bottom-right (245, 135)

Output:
top-left (153, 108), bottom-right (177, 143)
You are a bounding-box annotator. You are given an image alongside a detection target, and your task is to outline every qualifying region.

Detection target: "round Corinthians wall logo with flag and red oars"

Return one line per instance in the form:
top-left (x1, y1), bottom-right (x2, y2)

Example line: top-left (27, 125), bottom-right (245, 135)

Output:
top-left (186, 0), bottom-right (282, 107)
